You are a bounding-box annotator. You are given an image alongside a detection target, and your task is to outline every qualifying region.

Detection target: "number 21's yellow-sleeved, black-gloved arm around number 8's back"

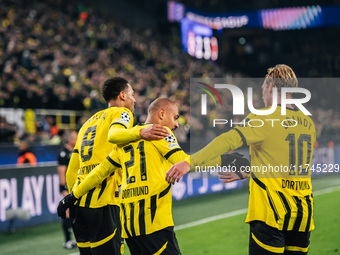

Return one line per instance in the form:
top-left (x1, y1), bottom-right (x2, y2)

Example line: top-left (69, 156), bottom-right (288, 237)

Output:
top-left (58, 150), bottom-right (121, 219)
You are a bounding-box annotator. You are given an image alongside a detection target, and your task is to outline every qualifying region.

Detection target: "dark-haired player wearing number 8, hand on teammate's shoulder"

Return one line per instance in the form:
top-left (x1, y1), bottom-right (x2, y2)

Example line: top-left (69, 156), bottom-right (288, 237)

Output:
top-left (58, 77), bottom-right (168, 255)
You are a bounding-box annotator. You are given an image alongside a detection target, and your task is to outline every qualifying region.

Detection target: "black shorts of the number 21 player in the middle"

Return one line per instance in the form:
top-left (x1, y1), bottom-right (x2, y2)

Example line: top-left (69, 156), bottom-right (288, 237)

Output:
top-left (125, 227), bottom-right (181, 255)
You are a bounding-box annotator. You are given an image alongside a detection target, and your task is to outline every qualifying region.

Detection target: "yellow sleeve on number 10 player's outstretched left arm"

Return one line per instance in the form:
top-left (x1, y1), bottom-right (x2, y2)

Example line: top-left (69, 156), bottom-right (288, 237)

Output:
top-left (190, 129), bottom-right (244, 168)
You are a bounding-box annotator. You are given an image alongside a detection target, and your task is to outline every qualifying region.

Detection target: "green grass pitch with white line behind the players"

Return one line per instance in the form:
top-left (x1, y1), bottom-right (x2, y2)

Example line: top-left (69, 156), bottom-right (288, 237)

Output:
top-left (0, 174), bottom-right (340, 255)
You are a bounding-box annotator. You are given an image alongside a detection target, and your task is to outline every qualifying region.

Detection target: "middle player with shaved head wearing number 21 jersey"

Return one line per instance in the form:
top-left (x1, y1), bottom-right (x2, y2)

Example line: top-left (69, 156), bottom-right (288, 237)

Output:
top-left (58, 98), bottom-right (188, 255)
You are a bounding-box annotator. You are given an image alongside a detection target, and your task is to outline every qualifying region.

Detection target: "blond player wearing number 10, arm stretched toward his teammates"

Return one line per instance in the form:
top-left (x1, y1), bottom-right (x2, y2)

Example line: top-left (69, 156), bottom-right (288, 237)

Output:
top-left (166, 65), bottom-right (316, 255)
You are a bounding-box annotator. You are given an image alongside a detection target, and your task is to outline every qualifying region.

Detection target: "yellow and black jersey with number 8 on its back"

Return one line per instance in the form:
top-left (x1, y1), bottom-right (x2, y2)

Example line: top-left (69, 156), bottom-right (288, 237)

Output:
top-left (67, 107), bottom-right (133, 208)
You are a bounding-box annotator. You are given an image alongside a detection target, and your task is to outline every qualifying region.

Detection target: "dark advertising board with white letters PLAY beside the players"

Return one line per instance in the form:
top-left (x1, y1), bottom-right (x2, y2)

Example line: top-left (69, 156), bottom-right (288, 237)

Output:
top-left (0, 166), bottom-right (62, 231)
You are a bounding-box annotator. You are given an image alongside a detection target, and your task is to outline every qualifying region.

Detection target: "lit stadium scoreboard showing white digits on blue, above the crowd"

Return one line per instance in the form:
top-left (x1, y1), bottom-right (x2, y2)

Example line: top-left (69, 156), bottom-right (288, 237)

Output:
top-left (181, 18), bottom-right (218, 61)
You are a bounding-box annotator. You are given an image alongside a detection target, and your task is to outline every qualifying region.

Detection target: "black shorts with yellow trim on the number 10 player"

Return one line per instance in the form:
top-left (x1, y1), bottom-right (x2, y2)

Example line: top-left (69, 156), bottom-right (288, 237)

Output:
top-left (249, 221), bottom-right (310, 255)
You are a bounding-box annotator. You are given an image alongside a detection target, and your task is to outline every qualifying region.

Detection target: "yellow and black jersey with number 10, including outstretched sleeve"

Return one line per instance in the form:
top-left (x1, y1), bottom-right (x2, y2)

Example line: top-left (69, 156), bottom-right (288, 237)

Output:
top-left (191, 106), bottom-right (316, 232)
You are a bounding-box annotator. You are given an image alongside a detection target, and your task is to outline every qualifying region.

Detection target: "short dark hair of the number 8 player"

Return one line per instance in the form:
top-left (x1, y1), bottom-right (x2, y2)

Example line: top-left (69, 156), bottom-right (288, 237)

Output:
top-left (102, 76), bottom-right (128, 103)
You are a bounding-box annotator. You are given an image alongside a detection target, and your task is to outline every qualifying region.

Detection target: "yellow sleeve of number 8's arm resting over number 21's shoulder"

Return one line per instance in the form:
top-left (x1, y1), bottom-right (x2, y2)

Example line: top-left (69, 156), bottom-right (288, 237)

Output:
top-left (108, 125), bottom-right (142, 144)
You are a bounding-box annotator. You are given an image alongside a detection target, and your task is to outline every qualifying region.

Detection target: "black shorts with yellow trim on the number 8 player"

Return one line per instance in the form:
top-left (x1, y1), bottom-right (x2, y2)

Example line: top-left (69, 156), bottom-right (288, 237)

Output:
top-left (70, 205), bottom-right (124, 255)
